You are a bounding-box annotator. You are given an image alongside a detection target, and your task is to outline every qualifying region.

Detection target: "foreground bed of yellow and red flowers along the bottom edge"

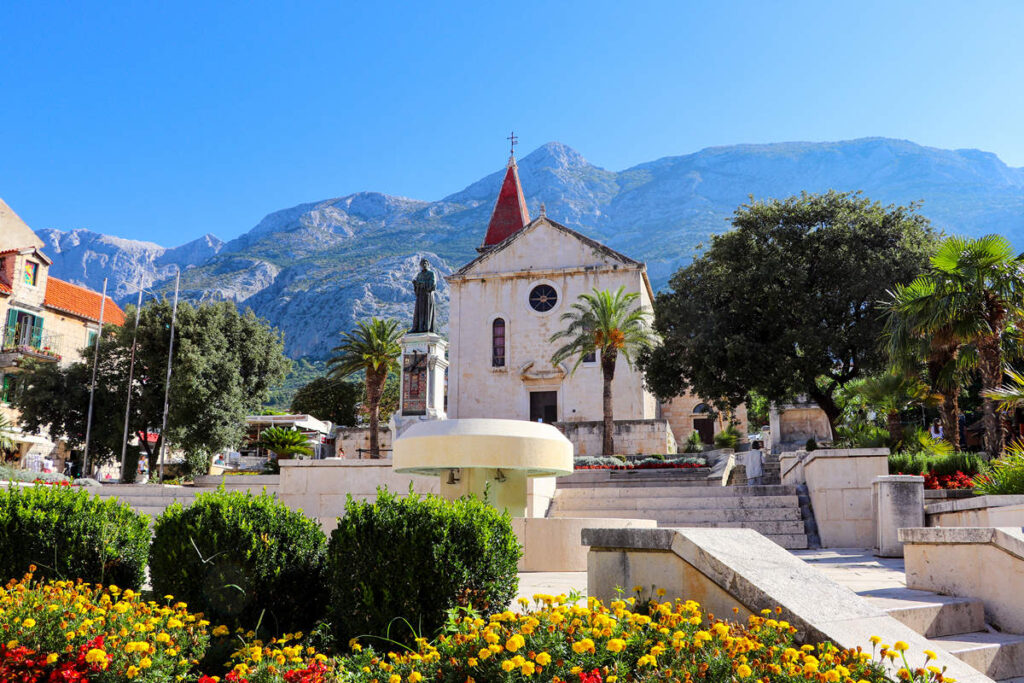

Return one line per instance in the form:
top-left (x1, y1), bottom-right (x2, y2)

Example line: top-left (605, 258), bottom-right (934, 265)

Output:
top-left (0, 574), bottom-right (943, 683)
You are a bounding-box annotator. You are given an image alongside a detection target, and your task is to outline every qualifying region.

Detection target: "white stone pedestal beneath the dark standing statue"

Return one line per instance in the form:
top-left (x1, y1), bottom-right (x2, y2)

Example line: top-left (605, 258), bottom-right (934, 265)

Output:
top-left (390, 332), bottom-right (447, 438)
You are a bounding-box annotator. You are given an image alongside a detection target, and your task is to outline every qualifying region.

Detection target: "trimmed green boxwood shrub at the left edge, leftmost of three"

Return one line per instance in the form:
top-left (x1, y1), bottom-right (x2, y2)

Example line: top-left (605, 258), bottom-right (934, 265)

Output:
top-left (0, 484), bottom-right (150, 589)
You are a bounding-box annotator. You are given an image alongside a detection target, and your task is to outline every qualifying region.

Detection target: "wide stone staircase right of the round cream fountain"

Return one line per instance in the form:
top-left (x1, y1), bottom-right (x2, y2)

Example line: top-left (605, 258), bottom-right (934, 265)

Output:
top-left (548, 470), bottom-right (808, 549)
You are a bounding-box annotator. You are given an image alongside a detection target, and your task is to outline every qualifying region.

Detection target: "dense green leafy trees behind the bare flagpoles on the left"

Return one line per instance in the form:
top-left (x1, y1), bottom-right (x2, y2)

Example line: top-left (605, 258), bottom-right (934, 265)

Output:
top-left (16, 300), bottom-right (290, 474)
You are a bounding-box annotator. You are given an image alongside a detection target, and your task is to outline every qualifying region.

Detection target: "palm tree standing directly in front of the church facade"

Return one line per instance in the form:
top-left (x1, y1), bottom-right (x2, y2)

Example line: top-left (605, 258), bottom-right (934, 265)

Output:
top-left (548, 287), bottom-right (657, 456)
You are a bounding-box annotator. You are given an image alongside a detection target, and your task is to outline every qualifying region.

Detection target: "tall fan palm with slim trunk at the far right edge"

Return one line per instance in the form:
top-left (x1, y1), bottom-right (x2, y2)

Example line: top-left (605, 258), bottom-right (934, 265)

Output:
top-left (929, 234), bottom-right (1024, 457)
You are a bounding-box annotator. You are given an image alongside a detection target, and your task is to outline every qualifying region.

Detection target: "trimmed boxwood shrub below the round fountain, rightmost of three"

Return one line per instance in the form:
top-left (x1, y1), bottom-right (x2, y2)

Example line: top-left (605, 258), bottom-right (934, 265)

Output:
top-left (327, 489), bottom-right (522, 643)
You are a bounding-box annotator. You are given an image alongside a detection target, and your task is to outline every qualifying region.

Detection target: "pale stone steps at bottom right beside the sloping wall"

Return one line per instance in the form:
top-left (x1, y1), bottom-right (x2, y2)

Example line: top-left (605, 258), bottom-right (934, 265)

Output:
top-left (797, 551), bottom-right (1024, 683)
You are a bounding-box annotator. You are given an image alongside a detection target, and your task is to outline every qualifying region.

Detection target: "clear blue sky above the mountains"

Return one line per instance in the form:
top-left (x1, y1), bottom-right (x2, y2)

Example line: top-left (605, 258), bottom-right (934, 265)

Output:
top-left (0, 0), bottom-right (1024, 246)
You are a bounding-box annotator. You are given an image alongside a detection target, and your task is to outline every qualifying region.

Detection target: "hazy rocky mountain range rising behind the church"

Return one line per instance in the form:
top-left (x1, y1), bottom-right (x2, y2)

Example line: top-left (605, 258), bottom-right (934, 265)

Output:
top-left (37, 138), bottom-right (1024, 358)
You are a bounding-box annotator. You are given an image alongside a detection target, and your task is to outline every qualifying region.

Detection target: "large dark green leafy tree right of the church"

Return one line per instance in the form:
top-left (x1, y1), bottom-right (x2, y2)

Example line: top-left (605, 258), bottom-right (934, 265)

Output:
top-left (642, 191), bottom-right (935, 436)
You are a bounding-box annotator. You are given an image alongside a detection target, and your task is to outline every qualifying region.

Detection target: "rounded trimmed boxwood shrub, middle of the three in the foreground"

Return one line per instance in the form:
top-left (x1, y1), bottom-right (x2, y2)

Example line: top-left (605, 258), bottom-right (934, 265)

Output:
top-left (150, 489), bottom-right (327, 634)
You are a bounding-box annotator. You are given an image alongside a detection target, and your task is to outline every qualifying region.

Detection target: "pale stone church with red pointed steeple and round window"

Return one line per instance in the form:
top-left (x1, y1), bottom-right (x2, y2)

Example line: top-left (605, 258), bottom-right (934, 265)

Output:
top-left (445, 156), bottom-right (737, 456)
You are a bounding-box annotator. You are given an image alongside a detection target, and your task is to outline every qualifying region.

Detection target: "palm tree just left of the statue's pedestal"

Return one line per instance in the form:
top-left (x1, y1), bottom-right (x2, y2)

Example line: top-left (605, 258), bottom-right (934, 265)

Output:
top-left (328, 317), bottom-right (406, 458)
